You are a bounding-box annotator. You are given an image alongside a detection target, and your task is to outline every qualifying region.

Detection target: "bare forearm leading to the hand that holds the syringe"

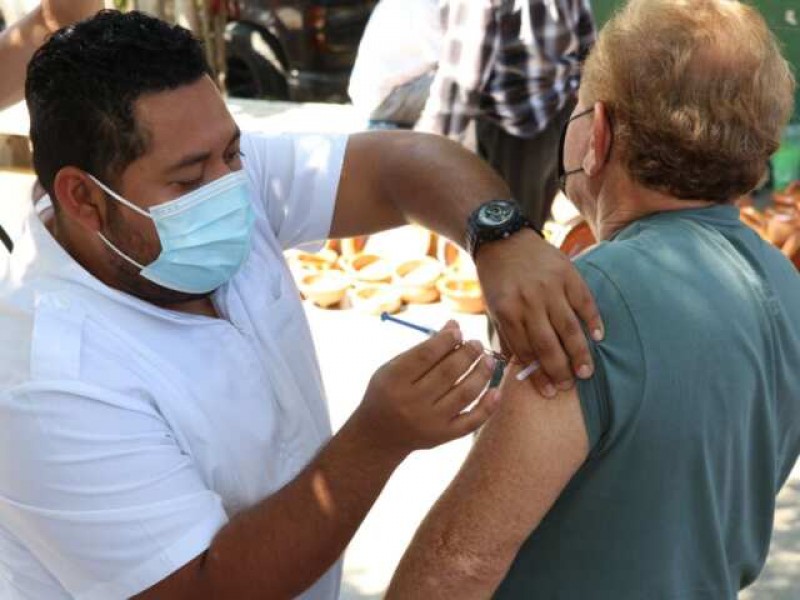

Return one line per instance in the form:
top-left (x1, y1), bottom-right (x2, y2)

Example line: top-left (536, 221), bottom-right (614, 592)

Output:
top-left (140, 412), bottom-right (405, 599)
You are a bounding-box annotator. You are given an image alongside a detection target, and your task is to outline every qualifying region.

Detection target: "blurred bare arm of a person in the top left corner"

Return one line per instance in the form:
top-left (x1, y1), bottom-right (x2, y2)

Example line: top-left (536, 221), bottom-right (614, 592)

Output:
top-left (0, 0), bottom-right (103, 110)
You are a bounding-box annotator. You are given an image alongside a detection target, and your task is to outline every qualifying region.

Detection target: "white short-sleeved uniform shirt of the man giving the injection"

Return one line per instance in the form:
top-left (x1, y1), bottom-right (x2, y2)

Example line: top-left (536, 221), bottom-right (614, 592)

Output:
top-left (0, 136), bottom-right (346, 600)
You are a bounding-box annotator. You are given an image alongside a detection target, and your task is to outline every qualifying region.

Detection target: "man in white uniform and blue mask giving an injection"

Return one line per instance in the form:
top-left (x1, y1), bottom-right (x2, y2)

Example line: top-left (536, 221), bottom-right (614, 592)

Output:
top-left (0, 12), bottom-right (602, 599)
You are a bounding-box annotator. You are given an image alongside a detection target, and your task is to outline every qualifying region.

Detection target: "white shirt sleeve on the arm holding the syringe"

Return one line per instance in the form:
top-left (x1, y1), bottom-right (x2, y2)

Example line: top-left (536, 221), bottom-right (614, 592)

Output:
top-left (0, 382), bottom-right (227, 600)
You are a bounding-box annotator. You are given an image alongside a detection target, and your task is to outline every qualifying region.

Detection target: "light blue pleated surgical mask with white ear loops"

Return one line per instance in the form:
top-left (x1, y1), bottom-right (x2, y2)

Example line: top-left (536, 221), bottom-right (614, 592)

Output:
top-left (89, 171), bottom-right (254, 294)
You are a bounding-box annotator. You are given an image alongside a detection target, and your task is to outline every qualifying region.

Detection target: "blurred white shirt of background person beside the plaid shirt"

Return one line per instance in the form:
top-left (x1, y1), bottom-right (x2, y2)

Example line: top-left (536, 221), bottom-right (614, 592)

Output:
top-left (348, 0), bottom-right (443, 115)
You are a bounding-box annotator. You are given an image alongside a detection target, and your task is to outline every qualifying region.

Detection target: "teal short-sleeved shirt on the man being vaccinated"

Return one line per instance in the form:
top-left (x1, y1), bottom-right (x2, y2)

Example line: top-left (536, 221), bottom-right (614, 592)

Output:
top-left (496, 206), bottom-right (800, 600)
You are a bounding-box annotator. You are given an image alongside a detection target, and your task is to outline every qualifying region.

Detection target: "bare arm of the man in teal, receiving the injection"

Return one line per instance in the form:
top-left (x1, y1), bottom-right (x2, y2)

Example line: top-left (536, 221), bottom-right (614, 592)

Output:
top-left (389, 371), bottom-right (589, 598)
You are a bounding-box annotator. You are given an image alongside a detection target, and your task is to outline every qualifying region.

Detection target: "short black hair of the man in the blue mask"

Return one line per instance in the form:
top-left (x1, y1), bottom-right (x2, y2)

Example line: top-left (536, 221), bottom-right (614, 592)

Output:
top-left (25, 10), bottom-right (210, 197)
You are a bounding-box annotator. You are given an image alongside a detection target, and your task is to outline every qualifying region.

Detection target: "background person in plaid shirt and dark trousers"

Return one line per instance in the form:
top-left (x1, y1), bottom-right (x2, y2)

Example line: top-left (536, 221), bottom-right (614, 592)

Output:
top-left (417, 0), bottom-right (595, 229)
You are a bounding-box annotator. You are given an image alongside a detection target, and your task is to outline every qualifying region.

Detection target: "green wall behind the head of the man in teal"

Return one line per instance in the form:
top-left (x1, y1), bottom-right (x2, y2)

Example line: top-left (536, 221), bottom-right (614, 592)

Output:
top-left (592, 0), bottom-right (800, 122)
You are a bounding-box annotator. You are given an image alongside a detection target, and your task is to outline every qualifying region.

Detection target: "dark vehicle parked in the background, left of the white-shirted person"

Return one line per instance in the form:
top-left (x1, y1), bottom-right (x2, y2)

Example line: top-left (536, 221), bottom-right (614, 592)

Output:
top-left (225, 0), bottom-right (377, 102)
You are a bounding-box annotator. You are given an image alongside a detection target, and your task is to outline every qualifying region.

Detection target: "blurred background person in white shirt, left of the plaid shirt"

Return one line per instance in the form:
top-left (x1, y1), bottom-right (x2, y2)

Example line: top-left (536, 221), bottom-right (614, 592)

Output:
top-left (348, 0), bottom-right (443, 129)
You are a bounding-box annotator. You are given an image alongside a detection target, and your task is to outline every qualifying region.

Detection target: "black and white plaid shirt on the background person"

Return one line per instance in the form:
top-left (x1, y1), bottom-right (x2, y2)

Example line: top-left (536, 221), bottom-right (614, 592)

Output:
top-left (417, 0), bottom-right (595, 140)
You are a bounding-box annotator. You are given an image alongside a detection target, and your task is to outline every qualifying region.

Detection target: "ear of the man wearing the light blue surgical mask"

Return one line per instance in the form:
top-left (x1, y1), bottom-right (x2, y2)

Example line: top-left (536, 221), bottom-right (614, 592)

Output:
top-left (53, 167), bottom-right (107, 231)
